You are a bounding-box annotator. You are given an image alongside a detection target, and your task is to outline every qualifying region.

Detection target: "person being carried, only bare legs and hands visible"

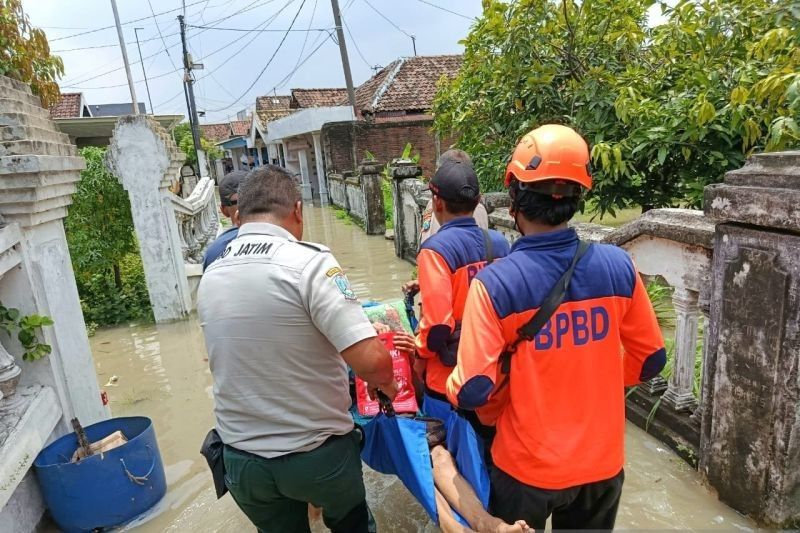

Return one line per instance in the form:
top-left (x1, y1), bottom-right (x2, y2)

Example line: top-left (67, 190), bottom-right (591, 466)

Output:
top-left (373, 322), bottom-right (532, 533)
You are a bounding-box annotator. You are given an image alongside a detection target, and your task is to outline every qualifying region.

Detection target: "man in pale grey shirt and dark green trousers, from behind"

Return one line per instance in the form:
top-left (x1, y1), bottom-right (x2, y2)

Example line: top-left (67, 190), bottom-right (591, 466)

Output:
top-left (197, 165), bottom-right (397, 533)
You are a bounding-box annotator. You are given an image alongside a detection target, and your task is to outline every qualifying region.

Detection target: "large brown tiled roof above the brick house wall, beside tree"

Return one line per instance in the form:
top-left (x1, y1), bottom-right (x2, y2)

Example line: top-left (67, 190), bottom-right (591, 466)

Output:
top-left (345, 55), bottom-right (463, 114)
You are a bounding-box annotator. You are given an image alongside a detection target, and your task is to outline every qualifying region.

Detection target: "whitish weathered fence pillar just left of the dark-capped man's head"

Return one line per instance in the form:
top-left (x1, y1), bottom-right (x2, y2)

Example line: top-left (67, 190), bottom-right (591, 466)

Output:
top-left (390, 161), bottom-right (425, 262)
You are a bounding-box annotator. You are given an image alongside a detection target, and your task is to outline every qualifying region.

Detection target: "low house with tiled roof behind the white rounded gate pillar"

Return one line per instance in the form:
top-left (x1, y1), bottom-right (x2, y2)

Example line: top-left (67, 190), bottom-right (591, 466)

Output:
top-left (50, 93), bottom-right (183, 148)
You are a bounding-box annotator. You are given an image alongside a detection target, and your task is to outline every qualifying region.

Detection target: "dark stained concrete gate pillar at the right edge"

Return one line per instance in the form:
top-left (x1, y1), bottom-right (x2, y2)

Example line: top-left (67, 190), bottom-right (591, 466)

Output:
top-left (700, 152), bottom-right (800, 528)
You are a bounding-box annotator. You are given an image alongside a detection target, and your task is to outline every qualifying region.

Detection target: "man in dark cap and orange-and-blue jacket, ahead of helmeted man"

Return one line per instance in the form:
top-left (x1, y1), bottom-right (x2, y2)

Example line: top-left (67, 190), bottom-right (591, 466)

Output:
top-left (417, 160), bottom-right (513, 442)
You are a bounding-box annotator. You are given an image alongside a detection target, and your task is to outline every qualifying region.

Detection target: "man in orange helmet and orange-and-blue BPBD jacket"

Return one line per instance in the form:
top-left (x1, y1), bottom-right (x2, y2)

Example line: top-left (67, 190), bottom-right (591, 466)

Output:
top-left (447, 125), bottom-right (666, 530)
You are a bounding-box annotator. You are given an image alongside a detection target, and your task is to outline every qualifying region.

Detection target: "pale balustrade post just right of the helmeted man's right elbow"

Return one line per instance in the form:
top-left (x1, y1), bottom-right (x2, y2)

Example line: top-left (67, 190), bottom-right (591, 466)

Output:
top-left (663, 287), bottom-right (699, 411)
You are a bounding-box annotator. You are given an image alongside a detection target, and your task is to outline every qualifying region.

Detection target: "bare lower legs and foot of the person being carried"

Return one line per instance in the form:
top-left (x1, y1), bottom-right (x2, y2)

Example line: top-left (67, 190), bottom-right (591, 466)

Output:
top-left (431, 445), bottom-right (533, 533)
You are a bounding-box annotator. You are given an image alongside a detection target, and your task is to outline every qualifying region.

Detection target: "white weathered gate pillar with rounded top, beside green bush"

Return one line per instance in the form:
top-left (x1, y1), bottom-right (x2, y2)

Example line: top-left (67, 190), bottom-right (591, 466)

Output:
top-left (106, 115), bottom-right (191, 322)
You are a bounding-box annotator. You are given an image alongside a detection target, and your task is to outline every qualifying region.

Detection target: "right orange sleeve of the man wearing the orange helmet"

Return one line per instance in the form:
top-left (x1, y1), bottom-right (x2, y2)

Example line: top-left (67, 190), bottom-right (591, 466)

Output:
top-left (620, 272), bottom-right (667, 387)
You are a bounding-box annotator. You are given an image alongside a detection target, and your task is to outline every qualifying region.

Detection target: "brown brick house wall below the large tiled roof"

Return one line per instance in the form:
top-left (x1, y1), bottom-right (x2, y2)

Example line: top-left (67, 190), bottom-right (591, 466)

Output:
top-left (322, 120), bottom-right (452, 176)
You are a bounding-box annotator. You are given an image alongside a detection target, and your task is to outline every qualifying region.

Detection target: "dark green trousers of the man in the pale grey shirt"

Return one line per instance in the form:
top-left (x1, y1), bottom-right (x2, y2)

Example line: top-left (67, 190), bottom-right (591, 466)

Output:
top-left (223, 432), bottom-right (374, 533)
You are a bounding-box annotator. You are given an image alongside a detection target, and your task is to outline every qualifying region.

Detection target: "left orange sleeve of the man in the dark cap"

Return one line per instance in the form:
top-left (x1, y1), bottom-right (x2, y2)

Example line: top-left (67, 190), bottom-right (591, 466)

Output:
top-left (417, 249), bottom-right (456, 358)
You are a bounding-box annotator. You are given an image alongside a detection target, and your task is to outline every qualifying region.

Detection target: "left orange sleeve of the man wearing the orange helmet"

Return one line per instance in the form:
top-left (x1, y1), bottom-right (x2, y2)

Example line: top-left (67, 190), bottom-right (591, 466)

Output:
top-left (447, 280), bottom-right (506, 409)
